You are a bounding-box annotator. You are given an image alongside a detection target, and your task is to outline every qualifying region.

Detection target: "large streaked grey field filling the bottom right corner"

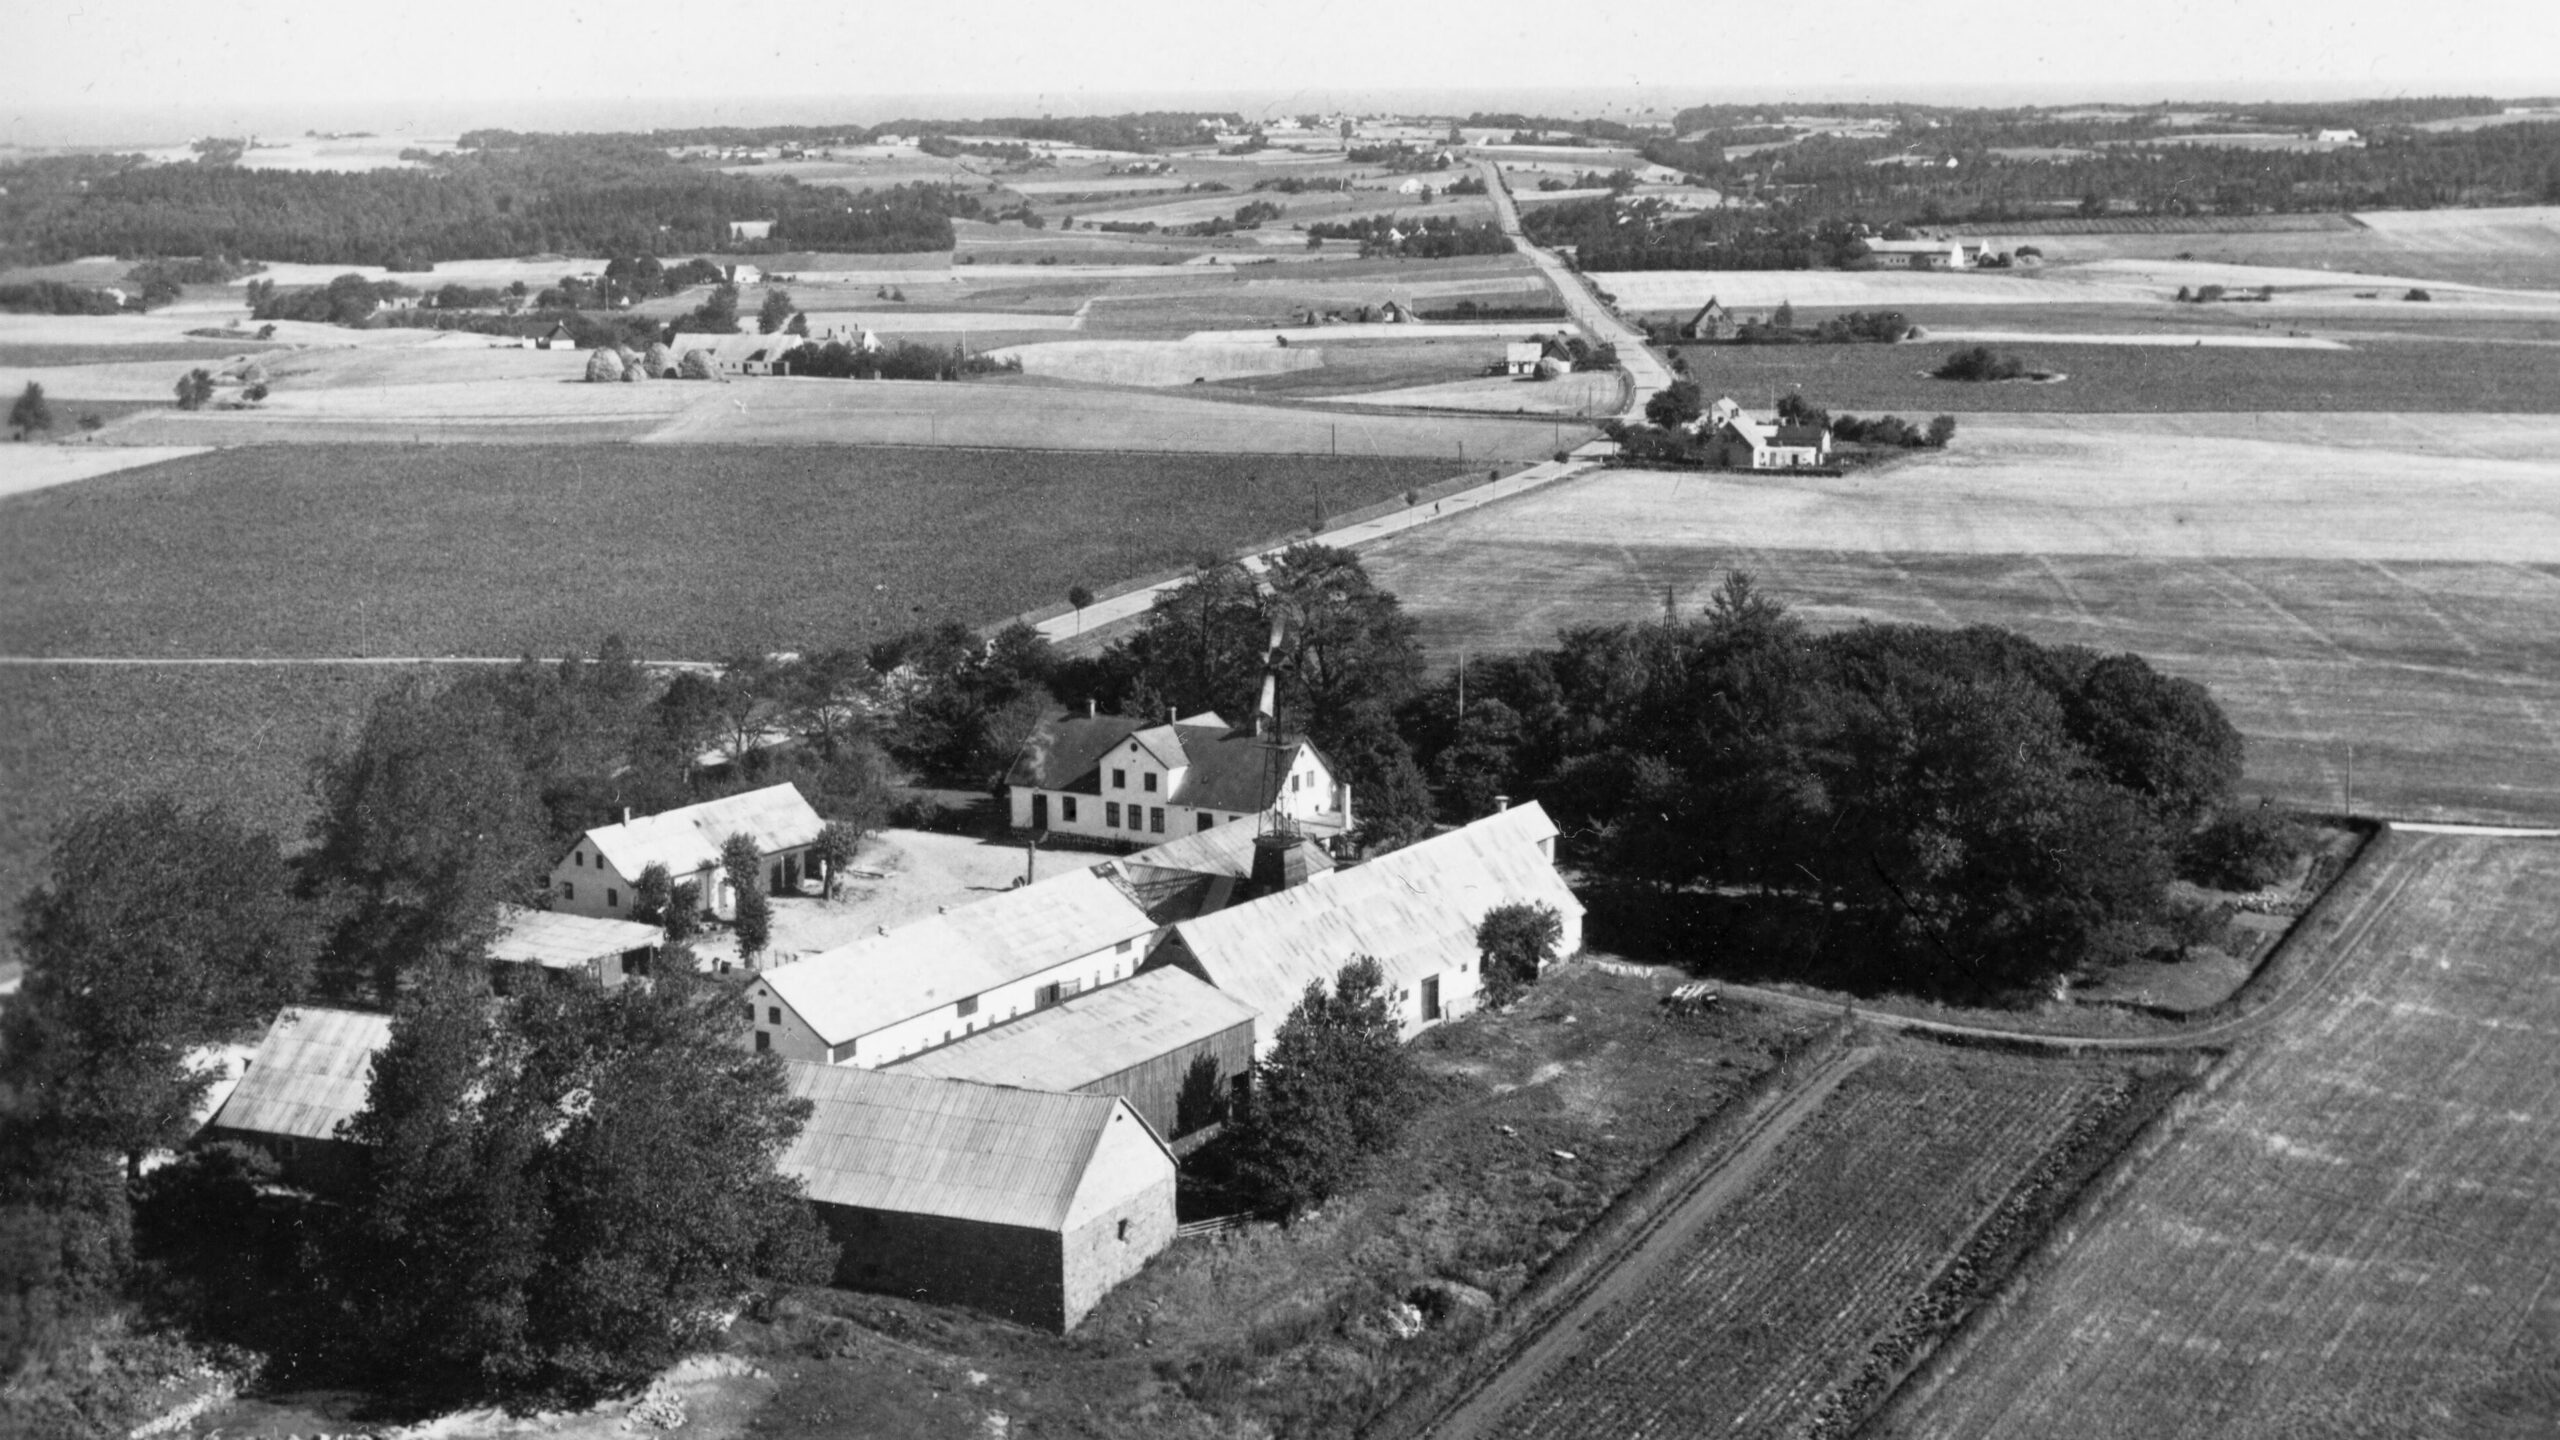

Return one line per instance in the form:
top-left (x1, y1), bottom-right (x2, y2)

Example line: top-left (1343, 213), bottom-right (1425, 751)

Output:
top-left (1882, 833), bottom-right (2560, 1440)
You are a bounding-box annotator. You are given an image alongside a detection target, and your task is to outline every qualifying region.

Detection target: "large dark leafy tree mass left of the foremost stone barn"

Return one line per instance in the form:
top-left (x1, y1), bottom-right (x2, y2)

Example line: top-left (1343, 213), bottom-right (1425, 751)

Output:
top-left (323, 966), bottom-right (835, 1409)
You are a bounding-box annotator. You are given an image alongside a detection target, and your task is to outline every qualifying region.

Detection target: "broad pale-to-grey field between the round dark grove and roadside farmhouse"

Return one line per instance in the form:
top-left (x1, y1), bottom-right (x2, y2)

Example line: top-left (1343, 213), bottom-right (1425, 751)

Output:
top-left (1367, 415), bottom-right (2560, 822)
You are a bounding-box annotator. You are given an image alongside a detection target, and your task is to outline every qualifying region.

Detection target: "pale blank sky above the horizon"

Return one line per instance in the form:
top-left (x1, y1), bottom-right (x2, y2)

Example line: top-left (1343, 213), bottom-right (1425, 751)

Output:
top-left (0, 0), bottom-right (2560, 136)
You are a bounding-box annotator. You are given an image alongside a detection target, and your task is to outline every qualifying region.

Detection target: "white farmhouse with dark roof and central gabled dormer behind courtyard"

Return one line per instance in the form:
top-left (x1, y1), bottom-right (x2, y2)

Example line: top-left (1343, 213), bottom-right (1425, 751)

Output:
top-left (1006, 705), bottom-right (1352, 843)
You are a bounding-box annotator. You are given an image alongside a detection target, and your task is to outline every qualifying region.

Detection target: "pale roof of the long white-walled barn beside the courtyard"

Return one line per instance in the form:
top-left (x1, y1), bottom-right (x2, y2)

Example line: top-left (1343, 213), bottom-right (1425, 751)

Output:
top-left (758, 855), bottom-right (1155, 1045)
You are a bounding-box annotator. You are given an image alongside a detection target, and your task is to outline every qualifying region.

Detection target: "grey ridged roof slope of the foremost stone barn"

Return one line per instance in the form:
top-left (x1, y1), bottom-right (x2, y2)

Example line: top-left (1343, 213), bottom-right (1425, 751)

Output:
top-left (778, 1061), bottom-right (1162, 1230)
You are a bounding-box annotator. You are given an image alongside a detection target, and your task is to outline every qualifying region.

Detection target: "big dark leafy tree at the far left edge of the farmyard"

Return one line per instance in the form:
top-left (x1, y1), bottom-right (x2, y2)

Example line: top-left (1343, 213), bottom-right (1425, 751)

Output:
top-left (0, 794), bottom-right (323, 1166)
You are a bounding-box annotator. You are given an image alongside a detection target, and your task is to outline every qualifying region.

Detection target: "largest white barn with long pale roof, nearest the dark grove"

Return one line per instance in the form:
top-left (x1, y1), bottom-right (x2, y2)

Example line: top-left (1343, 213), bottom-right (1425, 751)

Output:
top-left (1149, 802), bottom-right (1582, 1056)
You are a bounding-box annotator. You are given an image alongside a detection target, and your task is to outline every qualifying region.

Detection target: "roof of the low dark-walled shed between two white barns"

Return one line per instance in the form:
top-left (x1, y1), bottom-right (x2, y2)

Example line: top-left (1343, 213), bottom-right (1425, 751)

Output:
top-left (891, 969), bottom-right (1254, 1089)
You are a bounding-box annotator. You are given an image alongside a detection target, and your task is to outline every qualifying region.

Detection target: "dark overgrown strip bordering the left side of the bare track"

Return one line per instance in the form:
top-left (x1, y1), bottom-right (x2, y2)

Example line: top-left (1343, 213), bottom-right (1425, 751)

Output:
top-left (1359, 1015), bottom-right (1859, 1440)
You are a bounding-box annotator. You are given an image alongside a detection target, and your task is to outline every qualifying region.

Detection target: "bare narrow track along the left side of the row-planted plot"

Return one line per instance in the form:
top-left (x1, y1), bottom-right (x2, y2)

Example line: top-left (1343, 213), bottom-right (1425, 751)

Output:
top-left (1428, 1048), bottom-right (1874, 1440)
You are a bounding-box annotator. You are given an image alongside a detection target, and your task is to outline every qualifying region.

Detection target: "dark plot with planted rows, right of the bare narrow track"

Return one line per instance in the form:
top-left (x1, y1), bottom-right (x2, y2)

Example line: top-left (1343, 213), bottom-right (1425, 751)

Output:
top-left (1487, 1045), bottom-right (2115, 1440)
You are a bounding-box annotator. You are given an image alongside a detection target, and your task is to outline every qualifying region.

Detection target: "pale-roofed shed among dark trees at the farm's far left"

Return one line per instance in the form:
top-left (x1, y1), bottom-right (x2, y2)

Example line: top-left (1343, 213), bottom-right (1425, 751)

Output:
top-left (197, 1004), bottom-right (392, 1191)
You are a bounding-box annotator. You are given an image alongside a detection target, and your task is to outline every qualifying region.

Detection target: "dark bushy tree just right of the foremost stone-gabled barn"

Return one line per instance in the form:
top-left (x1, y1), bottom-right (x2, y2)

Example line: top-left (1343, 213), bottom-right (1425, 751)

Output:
top-left (1236, 956), bottom-right (1413, 1215)
